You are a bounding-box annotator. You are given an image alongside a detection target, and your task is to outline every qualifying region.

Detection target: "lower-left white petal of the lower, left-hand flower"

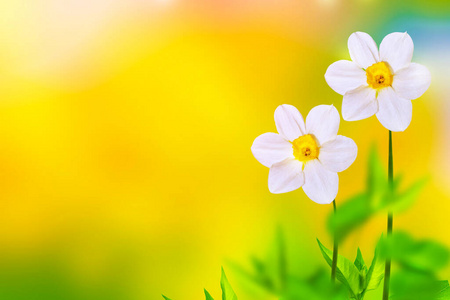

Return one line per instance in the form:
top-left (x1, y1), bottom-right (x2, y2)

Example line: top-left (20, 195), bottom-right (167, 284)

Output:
top-left (269, 158), bottom-right (305, 194)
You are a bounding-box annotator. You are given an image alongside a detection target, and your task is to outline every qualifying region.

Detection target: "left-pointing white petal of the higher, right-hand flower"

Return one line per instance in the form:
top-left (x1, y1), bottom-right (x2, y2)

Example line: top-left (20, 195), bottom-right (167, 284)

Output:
top-left (325, 60), bottom-right (367, 95)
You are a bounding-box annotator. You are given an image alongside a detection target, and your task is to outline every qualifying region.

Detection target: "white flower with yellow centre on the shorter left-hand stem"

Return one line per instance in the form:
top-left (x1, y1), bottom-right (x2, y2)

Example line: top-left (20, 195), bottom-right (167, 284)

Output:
top-left (252, 104), bottom-right (358, 204)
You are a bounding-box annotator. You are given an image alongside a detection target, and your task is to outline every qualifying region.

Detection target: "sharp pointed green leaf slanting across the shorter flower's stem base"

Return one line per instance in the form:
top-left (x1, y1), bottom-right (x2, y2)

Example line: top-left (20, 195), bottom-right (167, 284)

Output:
top-left (317, 239), bottom-right (360, 298)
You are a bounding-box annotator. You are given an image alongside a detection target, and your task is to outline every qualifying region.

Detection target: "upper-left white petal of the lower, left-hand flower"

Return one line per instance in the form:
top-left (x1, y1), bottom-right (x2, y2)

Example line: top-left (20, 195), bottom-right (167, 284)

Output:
top-left (275, 104), bottom-right (305, 141)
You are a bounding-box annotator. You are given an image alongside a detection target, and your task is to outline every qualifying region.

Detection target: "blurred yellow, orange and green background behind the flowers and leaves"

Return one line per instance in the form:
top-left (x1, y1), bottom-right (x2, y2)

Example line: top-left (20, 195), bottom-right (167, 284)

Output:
top-left (0, 0), bottom-right (450, 300)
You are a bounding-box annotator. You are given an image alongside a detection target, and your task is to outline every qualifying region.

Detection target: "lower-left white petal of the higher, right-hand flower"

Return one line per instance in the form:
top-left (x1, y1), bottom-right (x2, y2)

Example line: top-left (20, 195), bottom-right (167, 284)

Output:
top-left (342, 86), bottom-right (378, 121)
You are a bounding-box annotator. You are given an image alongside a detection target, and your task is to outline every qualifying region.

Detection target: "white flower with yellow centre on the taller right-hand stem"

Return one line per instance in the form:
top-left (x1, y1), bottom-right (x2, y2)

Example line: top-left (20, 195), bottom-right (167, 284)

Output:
top-left (325, 32), bottom-right (431, 131)
